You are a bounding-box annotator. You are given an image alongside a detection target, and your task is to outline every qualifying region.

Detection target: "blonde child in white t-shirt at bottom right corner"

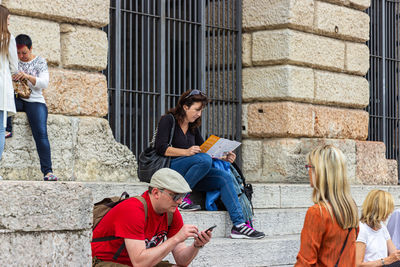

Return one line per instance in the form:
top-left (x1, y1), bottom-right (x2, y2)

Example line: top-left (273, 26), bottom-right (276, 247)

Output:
top-left (356, 190), bottom-right (400, 267)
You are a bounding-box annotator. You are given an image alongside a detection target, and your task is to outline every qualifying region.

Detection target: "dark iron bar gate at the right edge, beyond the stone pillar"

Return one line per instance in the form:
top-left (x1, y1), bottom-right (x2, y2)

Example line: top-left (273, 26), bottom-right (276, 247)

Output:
top-left (367, 0), bottom-right (400, 181)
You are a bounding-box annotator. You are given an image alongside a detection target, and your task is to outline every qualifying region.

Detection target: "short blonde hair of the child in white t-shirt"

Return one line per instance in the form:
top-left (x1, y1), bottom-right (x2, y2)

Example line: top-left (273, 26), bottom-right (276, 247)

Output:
top-left (361, 190), bottom-right (394, 229)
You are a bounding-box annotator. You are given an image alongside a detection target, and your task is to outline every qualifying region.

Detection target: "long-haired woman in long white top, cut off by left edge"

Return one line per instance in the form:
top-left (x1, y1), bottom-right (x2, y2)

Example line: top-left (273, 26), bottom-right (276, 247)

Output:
top-left (0, 5), bottom-right (18, 165)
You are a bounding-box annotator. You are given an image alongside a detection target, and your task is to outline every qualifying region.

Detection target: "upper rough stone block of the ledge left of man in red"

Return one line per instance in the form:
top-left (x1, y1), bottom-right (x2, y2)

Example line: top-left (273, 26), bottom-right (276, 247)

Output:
top-left (0, 181), bottom-right (93, 232)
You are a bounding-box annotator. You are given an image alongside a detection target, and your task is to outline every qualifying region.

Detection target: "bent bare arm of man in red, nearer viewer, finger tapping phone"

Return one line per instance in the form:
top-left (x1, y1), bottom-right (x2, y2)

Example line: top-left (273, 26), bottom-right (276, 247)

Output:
top-left (124, 225), bottom-right (198, 267)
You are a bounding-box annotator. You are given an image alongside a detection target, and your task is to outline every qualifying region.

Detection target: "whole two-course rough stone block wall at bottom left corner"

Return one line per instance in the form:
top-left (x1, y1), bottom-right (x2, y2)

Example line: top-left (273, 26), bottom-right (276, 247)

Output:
top-left (0, 181), bottom-right (93, 267)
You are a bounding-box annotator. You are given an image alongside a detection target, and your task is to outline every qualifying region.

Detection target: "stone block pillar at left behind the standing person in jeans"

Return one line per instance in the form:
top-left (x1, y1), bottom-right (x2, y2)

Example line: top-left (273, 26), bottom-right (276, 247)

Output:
top-left (0, 0), bottom-right (136, 181)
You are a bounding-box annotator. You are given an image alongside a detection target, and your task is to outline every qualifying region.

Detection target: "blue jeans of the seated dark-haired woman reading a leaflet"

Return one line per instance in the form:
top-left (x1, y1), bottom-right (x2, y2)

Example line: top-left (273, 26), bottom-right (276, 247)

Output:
top-left (170, 153), bottom-right (245, 225)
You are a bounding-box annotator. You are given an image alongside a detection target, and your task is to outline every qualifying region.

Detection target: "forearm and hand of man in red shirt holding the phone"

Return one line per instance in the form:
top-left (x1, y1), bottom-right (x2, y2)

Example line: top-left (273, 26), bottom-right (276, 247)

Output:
top-left (172, 231), bottom-right (212, 266)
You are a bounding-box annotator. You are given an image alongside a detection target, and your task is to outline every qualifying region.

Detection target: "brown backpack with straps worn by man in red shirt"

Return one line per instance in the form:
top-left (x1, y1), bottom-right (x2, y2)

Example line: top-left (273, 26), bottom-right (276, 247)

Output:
top-left (92, 192), bottom-right (174, 260)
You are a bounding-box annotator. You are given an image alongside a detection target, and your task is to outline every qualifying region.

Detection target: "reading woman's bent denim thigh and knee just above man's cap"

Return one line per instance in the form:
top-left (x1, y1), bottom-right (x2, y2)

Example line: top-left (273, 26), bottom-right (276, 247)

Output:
top-left (170, 153), bottom-right (212, 189)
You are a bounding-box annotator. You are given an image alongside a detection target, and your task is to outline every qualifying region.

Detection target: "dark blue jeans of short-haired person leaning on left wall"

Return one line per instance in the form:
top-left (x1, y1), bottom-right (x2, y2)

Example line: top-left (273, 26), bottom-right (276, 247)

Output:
top-left (7, 98), bottom-right (53, 175)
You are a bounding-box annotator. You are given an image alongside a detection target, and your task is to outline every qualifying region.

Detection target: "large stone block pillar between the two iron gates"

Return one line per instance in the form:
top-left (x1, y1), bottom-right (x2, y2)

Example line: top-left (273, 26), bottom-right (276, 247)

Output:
top-left (242, 0), bottom-right (397, 184)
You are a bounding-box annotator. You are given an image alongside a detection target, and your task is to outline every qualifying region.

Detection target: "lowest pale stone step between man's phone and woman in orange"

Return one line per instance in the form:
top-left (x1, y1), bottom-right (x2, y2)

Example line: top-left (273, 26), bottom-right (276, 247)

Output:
top-left (166, 235), bottom-right (300, 267)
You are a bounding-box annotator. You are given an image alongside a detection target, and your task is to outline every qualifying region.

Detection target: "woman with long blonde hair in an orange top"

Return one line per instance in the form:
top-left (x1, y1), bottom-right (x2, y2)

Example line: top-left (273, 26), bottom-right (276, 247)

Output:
top-left (295, 145), bottom-right (358, 267)
